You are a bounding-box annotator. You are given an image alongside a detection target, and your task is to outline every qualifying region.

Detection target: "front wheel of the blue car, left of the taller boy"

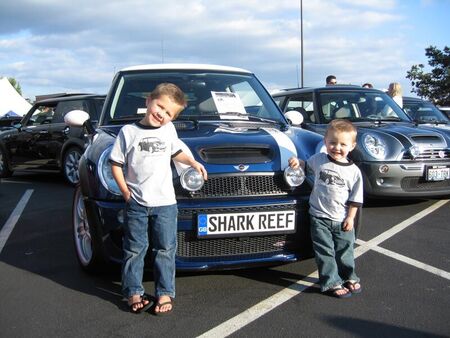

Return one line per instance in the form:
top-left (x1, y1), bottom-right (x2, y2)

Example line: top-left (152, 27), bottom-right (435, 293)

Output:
top-left (72, 186), bottom-right (108, 274)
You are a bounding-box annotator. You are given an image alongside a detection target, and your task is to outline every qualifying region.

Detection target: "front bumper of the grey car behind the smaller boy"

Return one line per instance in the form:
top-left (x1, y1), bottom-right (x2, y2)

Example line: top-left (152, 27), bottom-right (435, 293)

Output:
top-left (359, 161), bottom-right (450, 198)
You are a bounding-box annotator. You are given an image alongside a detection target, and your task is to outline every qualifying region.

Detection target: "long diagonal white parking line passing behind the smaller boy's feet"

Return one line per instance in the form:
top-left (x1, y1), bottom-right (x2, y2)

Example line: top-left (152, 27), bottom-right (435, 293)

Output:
top-left (198, 200), bottom-right (450, 337)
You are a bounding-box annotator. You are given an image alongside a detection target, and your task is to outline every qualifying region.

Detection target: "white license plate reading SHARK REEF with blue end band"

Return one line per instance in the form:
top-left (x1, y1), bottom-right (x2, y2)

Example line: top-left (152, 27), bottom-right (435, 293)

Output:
top-left (197, 210), bottom-right (296, 238)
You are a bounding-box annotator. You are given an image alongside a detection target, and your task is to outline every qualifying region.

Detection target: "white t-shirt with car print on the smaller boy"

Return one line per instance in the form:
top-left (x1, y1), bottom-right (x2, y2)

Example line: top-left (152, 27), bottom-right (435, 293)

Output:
top-left (307, 153), bottom-right (363, 222)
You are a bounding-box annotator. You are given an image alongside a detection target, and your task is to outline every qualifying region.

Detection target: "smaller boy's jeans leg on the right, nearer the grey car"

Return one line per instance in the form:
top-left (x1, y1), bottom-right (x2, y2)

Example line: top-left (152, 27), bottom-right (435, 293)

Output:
top-left (334, 225), bottom-right (359, 282)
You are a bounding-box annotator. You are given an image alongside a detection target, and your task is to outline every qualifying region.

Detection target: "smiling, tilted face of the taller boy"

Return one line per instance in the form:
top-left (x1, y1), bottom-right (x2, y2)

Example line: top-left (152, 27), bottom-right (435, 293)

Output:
top-left (146, 95), bottom-right (183, 127)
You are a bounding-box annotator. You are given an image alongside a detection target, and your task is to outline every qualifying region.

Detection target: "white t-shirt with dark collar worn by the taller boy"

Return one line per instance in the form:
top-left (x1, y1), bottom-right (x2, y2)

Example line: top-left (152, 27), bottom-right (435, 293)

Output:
top-left (110, 122), bottom-right (181, 207)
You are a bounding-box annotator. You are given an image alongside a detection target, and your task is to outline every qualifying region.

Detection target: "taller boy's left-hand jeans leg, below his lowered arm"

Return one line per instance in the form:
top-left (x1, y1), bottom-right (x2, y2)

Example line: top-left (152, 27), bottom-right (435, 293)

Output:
top-left (122, 199), bottom-right (148, 299)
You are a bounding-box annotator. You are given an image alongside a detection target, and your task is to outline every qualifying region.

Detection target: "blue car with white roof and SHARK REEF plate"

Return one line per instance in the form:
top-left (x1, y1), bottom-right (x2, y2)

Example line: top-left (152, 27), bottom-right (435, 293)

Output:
top-left (66, 64), bottom-right (321, 271)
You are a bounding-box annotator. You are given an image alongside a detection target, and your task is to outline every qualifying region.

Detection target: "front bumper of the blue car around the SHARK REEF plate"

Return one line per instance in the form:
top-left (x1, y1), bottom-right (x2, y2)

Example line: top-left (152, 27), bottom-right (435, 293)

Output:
top-left (85, 196), bottom-right (312, 271)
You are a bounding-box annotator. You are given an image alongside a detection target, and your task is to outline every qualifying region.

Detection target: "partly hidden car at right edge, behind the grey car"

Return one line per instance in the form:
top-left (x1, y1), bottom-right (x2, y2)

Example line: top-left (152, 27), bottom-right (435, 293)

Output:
top-left (403, 97), bottom-right (450, 130)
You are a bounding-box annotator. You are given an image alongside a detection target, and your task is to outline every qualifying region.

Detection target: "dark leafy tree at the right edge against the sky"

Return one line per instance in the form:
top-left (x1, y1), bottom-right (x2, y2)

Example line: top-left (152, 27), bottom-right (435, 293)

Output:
top-left (406, 46), bottom-right (450, 106)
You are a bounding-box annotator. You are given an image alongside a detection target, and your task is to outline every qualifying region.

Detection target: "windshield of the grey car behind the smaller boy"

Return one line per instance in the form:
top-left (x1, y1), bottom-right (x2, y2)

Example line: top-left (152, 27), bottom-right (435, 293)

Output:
top-left (319, 91), bottom-right (411, 123)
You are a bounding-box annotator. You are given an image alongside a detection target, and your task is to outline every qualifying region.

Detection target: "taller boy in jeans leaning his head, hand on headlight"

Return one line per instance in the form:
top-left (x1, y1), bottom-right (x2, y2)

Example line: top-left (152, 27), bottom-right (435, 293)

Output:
top-left (110, 83), bottom-right (207, 314)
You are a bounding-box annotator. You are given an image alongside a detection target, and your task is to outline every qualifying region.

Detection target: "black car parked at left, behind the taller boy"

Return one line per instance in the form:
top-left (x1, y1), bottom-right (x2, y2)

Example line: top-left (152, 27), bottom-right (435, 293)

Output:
top-left (0, 94), bottom-right (105, 185)
